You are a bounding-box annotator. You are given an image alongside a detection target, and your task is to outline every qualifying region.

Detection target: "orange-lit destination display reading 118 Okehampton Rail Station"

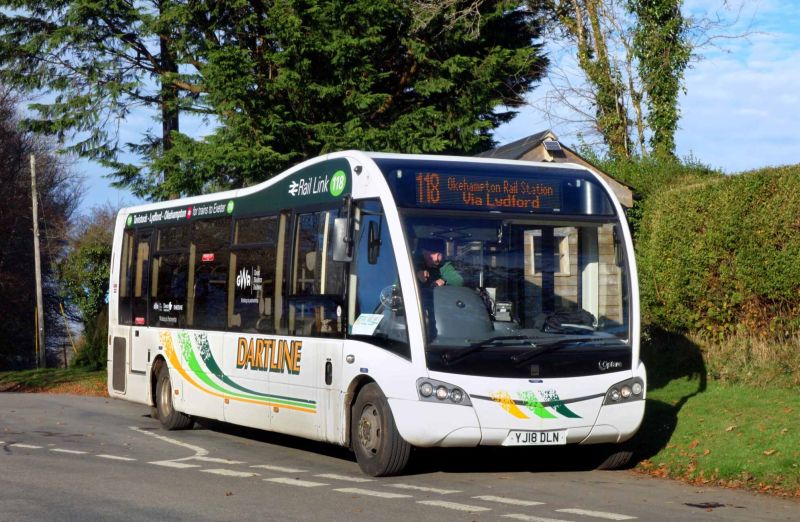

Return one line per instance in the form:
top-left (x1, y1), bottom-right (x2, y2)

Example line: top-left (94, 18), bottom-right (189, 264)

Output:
top-left (415, 171), bottom-right (562, 212)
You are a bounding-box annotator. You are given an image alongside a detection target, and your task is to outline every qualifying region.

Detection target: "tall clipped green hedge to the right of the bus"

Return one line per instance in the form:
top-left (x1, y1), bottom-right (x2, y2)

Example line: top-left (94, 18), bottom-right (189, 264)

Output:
top-left (636, 165), bottom-right (800, 338)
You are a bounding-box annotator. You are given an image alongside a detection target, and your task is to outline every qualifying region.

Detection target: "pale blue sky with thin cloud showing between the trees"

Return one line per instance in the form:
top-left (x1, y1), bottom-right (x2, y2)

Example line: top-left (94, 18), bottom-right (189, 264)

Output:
top-left (74, 0), bottom-right (800, 212)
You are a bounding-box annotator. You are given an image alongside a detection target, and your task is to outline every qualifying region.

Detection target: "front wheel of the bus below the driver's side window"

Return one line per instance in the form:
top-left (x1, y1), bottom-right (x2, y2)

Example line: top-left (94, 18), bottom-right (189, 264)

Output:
top-left (350, 383), bottom-right (411, 477)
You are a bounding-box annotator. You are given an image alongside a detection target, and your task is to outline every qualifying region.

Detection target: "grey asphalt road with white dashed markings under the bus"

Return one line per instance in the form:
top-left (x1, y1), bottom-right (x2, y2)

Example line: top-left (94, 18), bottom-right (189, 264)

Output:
top-left (0, 393), bottom-right (800, 522)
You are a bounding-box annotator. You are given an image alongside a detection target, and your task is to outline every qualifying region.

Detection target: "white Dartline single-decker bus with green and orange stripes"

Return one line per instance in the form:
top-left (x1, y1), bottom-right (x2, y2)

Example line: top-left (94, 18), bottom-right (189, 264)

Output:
top-left (108, 151), bottom-right (646, 476)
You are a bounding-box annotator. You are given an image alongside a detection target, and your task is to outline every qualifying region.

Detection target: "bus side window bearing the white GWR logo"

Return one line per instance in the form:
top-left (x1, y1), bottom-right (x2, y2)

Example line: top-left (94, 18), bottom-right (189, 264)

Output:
top-left (228, 216), bottom-right (278, 333)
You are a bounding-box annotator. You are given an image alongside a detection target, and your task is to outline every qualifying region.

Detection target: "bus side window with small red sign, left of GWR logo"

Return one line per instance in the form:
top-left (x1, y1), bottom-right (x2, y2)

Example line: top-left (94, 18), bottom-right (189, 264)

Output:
top-left (187, 217), bottom-right (231, 330)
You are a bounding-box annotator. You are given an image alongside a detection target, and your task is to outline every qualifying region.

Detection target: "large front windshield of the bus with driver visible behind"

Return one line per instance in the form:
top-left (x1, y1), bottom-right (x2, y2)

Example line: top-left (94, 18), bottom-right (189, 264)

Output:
top-left (403, 209), bottom-right (630, 377)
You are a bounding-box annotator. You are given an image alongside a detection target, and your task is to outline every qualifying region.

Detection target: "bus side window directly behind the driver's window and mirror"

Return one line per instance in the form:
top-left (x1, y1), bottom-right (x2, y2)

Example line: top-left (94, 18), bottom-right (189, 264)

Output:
top-left (287, 210), bottom-right (345, 336)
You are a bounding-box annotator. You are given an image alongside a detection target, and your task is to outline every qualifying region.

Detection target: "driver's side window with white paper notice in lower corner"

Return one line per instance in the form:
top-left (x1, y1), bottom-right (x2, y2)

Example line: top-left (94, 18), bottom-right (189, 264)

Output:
top-left (348, 201), bottom-right (411, 359)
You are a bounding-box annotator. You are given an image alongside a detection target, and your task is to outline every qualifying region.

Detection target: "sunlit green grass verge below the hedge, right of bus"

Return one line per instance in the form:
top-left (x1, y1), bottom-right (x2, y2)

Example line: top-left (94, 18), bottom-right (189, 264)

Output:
top-left (636, 379), bottom-right (800, 497)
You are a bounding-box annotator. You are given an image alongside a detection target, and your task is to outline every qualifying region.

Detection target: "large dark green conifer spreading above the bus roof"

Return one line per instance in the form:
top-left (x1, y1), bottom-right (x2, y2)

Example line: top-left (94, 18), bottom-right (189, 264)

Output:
top-left (0, 0), bottom-right (547, 199)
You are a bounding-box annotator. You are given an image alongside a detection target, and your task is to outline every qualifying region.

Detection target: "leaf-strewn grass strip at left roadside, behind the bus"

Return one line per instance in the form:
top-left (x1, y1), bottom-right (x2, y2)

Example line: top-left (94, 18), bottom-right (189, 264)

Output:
top-left (0, 368), bottom-right (108, 397)
